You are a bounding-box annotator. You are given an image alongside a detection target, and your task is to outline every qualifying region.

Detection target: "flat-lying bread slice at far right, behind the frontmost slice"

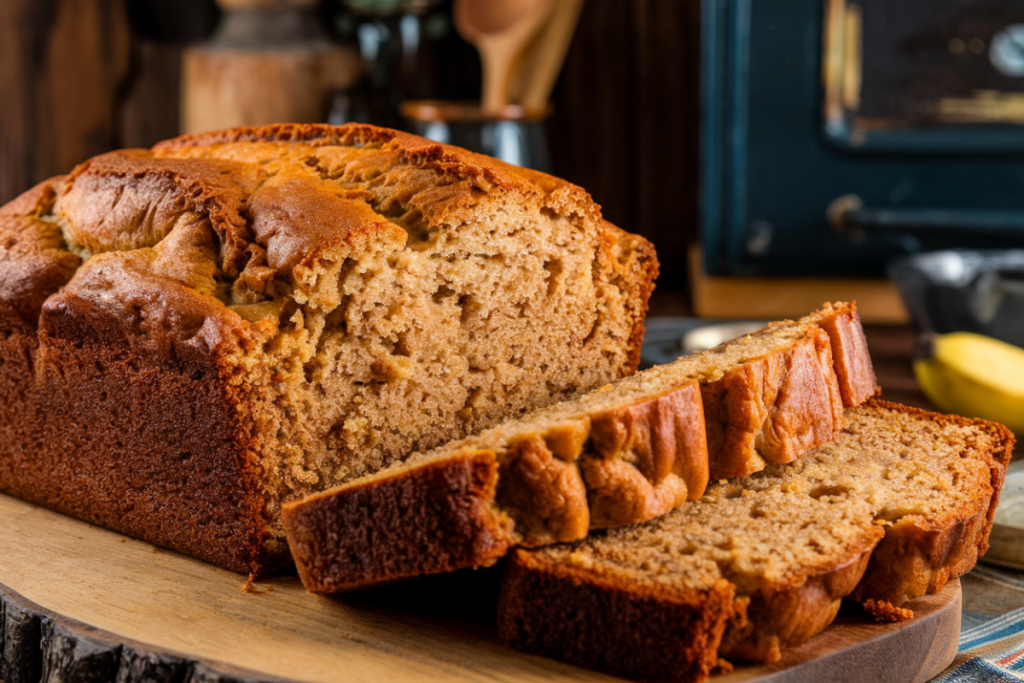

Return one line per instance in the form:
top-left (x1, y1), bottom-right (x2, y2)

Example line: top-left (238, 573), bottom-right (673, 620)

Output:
top-left (744, 400), bottom-right (1014, 613)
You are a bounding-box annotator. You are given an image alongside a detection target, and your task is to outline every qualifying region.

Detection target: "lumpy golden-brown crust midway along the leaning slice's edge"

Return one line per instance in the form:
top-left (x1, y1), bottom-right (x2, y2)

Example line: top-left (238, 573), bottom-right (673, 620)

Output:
top-left (497, 380), bottom-right (708, 547)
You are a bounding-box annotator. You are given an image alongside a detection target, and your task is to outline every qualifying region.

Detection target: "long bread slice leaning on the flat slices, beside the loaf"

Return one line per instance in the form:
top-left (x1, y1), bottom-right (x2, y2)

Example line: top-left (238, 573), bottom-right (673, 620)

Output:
top-left (283, 303), bottom-right (876, 592)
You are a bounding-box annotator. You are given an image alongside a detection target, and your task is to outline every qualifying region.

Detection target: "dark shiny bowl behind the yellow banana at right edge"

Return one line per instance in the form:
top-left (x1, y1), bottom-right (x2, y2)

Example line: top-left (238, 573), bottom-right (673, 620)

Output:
top-left (889, 250), bottom-right (1024, 346)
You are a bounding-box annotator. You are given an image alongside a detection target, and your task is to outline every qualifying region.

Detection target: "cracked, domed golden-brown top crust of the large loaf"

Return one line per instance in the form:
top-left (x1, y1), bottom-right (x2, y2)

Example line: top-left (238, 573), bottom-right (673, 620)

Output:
top-left (28, 125), bottom-right (600, 352)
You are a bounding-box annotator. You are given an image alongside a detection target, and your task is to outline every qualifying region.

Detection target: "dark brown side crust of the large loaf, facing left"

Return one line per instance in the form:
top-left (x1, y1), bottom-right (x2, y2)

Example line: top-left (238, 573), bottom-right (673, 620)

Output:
top-left (0, 178), bottom-right (272, 571)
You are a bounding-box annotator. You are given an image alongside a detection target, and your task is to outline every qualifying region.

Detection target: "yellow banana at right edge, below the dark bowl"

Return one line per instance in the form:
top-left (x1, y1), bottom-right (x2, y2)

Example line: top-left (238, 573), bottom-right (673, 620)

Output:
top-left (913, 332), bottom-right (1024, 434)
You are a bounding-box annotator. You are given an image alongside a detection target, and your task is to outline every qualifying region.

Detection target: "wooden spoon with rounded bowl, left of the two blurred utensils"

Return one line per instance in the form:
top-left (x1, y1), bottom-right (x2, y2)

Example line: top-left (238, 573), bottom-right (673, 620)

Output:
top-left (454, 0), bottom-right (555, 114)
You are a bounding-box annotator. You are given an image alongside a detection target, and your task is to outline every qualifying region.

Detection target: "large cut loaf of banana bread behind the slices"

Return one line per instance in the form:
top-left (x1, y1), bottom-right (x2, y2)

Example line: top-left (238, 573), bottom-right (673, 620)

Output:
top-left (0, 125), bottom-right (657, 571)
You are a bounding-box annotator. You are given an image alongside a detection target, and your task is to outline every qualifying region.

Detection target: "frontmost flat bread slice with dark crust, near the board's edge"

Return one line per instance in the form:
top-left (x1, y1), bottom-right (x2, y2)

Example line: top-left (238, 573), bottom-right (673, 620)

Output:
top-left (499, 483), bottom-right (883, 680)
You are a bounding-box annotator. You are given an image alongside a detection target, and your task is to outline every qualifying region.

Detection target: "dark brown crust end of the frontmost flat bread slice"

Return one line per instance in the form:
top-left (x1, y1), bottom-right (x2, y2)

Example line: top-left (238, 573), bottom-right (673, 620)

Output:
top-left (498, 550), bottom-right (744, 681)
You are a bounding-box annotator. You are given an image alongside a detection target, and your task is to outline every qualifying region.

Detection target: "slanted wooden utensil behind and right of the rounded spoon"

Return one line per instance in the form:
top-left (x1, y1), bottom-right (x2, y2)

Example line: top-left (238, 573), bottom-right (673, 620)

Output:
top-left (511, 0), bottom-right (584, 112)
